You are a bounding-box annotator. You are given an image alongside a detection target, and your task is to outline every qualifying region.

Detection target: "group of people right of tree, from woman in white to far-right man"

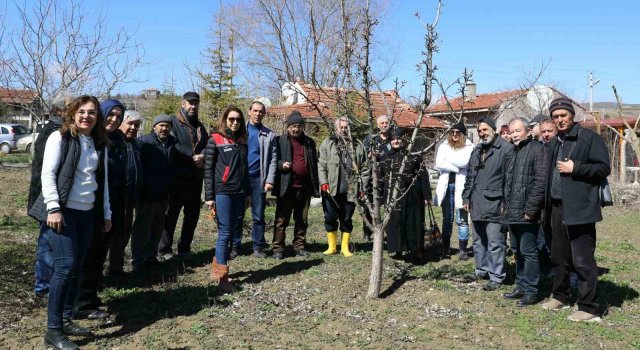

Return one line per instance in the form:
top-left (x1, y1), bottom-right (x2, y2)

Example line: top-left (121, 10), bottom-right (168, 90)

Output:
top-left (435, 97), bottom-right (610, 321)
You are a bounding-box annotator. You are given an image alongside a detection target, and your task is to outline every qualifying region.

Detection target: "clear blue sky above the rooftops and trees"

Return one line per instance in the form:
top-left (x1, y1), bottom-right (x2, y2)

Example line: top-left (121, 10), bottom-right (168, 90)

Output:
top-left (0, 0), bottom-right (640, 103)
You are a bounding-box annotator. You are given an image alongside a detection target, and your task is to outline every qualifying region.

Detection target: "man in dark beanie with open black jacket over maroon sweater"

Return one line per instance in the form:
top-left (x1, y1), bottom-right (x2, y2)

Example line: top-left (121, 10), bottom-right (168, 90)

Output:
top-left (269, 111), bottom-right (320, 260)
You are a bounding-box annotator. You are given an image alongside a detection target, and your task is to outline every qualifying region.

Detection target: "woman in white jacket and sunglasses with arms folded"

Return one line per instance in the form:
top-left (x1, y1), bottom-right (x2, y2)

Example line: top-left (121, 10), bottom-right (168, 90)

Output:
top-left (435, 121), bottom-right (473, 260)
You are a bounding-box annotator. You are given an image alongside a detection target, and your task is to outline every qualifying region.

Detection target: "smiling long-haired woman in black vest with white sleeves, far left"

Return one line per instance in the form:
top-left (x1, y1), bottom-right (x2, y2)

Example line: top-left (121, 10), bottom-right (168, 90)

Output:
top-left (29, 95), bottom-right (111, 349)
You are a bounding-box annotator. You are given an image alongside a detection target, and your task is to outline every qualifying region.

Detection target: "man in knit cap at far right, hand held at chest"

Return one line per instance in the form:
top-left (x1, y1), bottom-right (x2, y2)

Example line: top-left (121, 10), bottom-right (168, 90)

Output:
top-left (542, 97), bottom-right (611, 322)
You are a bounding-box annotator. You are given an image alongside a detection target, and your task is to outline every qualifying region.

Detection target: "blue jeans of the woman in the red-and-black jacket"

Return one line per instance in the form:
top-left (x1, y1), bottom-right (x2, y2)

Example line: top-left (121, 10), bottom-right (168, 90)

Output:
top-left (216, 193), bottom-right (247, 265)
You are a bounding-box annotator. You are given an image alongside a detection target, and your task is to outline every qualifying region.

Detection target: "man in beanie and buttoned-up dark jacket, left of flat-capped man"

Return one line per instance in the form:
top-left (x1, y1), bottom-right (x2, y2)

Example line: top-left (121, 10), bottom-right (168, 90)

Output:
top-left (131, 114), bottom-right (176, 273)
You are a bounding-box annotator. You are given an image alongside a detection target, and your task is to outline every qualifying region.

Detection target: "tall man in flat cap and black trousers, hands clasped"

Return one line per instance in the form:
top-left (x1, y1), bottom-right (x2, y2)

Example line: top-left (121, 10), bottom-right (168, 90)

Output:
top-left (158, 91), bottom-right (208, 260)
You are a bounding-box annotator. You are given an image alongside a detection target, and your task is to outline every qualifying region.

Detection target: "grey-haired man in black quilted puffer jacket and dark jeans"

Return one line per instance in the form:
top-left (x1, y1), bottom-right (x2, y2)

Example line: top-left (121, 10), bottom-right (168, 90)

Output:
top-left (502, 118), bottom-right (546, 306)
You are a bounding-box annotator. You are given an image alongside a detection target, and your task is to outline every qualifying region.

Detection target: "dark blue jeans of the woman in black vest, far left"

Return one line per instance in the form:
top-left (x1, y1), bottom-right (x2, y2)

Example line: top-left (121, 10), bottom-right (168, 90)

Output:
top-left (47, 208), bottom-right (94, 329)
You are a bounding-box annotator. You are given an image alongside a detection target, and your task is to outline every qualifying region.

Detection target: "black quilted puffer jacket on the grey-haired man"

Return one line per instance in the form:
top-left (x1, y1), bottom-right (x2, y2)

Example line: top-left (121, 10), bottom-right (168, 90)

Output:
top-left (502, 137), bottom-right (547, 224)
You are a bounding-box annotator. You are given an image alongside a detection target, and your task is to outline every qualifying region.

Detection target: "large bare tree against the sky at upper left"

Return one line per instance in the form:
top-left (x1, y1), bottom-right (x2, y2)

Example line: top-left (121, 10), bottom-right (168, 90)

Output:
top-left (0, 0), bottom-right (144, 120)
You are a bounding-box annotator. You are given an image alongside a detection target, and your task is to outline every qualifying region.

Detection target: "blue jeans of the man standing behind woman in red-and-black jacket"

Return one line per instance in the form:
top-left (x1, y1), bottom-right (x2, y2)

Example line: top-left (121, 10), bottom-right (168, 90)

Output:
top-left (244, 174), bottom-right (267, 251)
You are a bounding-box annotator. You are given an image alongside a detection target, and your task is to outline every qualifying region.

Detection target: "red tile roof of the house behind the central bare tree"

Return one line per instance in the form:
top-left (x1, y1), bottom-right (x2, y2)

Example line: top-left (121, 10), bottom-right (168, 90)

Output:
top-left (267, 84), bottom-right (445, 128)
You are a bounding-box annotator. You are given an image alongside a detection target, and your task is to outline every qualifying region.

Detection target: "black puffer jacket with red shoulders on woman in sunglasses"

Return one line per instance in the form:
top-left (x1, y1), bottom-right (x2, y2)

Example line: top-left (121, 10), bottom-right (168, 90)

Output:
top-left (204, 132), bottom-right (250, 201)
